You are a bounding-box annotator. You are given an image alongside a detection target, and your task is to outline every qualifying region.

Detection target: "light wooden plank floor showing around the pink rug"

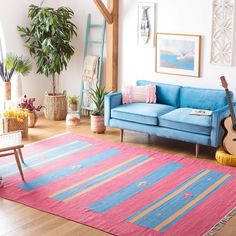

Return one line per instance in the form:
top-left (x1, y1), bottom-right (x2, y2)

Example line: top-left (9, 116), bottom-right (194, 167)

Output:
top-left (0, 118), bottom-right (236, 236)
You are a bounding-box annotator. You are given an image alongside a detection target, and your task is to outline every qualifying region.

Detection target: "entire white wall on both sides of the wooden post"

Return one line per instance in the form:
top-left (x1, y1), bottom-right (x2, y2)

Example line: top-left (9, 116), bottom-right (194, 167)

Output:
top-left (0, 0), bottom-right (236, 101)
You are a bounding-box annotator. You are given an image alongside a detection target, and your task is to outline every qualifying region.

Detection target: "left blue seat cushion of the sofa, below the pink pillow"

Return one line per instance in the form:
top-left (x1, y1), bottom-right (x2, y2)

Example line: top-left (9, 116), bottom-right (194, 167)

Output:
top-left (111, 103), bottom-right (175, 125)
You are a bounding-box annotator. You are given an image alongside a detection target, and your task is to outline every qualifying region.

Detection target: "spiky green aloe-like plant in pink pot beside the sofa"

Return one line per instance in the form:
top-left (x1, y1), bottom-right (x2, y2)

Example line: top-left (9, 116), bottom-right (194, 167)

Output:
top-left (90, 84), bottom-right (108, 134)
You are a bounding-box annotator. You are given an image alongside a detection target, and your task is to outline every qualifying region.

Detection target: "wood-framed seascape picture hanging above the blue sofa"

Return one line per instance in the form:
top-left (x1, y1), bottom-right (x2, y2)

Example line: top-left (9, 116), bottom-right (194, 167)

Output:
top-left (156, 33), bottom-right (201, 77)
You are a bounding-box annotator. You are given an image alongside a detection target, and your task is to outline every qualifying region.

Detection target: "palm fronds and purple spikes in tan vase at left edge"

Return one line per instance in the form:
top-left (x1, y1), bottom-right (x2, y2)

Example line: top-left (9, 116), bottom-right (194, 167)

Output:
top-left (0, 53), bottom-right (31, 100)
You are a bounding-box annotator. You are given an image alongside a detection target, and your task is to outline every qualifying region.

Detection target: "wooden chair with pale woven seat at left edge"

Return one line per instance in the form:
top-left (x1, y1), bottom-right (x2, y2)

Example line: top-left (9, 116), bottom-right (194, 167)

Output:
top-left (0, 131), bottom-right (25, 181)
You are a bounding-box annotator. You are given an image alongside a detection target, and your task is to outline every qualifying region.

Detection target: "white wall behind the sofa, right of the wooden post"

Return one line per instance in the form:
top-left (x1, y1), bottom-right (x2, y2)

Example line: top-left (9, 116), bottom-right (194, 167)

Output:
top-left (119, 0), bottom-right (236, 95)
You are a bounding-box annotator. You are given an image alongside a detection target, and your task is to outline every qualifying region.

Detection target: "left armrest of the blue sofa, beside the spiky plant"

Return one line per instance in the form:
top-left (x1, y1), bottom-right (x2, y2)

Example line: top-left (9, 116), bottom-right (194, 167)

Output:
top-left (104, 92), bottom-right (122, 126)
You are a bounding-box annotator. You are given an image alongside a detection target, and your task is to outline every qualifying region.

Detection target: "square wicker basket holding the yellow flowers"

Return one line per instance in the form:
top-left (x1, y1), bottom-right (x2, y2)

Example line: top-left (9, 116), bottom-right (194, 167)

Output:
top-left (4, 117), bottom-right (28, 138)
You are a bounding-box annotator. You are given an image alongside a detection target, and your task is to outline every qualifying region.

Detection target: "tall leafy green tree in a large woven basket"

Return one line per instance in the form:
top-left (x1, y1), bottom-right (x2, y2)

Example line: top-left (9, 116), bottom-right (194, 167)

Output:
top-left (18, 5), bottom-right (77, 120)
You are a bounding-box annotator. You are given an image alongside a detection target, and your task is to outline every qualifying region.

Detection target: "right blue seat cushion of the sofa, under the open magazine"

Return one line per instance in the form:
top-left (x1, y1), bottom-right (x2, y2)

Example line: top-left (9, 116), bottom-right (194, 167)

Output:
top-left (159, 108), bottom-right (212, 135)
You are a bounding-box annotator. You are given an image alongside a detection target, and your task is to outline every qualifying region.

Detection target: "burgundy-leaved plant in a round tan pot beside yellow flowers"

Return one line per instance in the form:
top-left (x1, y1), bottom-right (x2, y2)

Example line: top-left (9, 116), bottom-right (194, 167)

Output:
top-left (18, 95), bottom-right (43, 128)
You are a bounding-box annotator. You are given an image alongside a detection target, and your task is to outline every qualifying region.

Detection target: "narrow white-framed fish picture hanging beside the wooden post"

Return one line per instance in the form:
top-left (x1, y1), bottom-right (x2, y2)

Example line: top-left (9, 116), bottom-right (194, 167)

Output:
top-left (138, 2), bottom-right (155, 47)
